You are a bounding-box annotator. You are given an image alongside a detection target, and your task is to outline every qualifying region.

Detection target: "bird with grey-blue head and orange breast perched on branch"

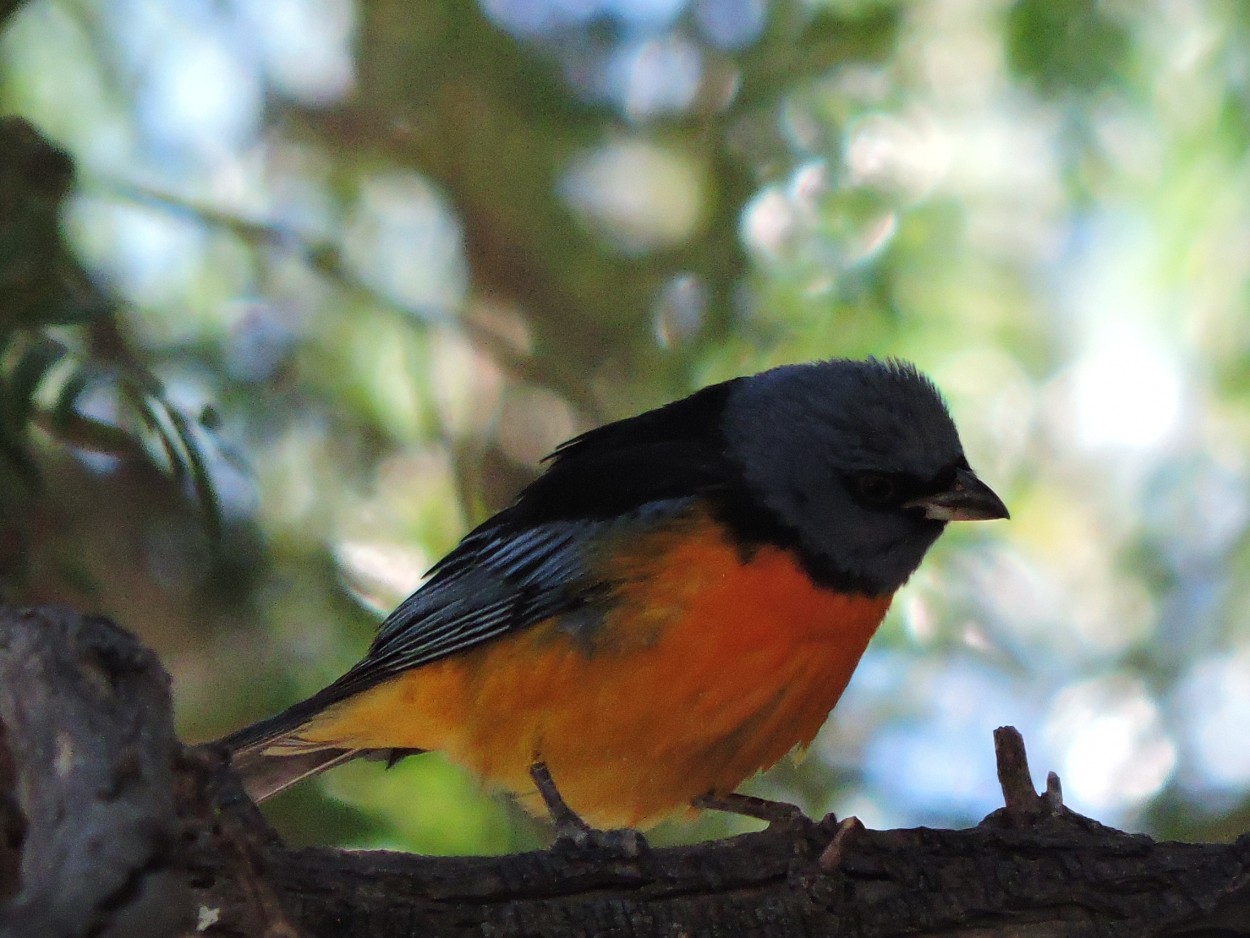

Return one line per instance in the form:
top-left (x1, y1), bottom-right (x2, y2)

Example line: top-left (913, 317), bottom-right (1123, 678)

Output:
top-left (220, 358), bottom-right (1009, 838)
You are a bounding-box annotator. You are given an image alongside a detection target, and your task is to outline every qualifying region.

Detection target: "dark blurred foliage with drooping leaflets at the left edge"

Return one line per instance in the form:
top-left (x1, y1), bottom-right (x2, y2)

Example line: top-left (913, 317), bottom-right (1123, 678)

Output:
top-left (0, 118), bottom-right (220, 578)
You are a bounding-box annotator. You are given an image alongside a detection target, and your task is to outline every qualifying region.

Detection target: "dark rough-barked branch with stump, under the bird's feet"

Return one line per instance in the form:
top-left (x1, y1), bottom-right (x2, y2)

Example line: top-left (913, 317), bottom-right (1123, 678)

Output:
top-left (0, 608), bottom-right (1250, 938)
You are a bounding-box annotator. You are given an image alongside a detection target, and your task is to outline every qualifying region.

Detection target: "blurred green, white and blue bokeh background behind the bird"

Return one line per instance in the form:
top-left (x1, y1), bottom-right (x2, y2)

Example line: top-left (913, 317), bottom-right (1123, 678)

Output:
top-left (0, 0), bottom-right (1250, 853)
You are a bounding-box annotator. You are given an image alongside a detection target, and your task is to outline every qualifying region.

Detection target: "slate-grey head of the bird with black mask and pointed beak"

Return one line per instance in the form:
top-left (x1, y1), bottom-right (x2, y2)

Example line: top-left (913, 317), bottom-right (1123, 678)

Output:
top-left (724, 359), bottom-right (1008, 594)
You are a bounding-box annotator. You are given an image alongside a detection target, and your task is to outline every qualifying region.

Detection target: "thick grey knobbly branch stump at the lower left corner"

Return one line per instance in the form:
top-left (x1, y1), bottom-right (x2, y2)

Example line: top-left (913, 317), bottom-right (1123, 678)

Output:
top-left (0, 609), bottom-right (190, 938)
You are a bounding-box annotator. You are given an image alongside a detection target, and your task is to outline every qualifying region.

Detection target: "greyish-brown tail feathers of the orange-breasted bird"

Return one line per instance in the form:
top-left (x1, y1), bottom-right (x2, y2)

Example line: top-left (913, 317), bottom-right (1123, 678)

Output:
top-left (218, 694), bottom-right (421, 804)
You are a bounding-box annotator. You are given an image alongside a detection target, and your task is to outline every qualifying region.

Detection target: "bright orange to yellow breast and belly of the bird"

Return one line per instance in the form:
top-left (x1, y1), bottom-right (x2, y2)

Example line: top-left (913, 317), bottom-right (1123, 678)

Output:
top-left (300, 518), bottom-right (890, 827)
